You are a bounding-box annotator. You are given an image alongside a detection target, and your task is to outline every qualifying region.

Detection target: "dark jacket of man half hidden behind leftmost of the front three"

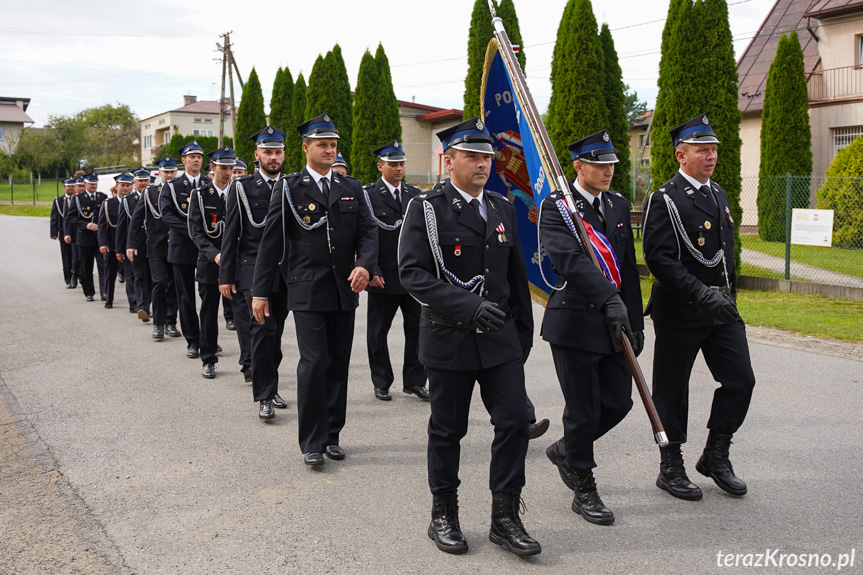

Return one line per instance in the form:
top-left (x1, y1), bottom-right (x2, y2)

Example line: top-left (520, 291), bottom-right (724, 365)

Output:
top-left (363, 178), bottom-right (422, 295)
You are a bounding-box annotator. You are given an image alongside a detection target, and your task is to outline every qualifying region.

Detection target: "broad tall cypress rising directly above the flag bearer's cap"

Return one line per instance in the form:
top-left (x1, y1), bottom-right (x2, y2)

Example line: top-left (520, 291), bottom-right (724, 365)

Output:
top-left (548, 0), bottom-right (605, 178)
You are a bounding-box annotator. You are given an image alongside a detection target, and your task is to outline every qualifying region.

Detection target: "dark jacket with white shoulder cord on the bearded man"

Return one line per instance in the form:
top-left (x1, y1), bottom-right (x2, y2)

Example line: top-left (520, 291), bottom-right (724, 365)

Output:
top-left (219, 172), bottom-right (286, 291)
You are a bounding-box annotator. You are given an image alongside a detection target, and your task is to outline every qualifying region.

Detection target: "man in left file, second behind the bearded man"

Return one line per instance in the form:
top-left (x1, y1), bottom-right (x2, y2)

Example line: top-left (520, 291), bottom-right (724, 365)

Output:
top-left (159, 140), bottom-right (210, 359)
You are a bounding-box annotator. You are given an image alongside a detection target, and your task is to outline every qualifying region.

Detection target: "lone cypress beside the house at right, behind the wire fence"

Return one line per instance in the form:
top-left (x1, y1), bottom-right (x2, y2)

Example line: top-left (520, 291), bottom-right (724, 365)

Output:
top-left (760, 31), bottom-right (812, 241)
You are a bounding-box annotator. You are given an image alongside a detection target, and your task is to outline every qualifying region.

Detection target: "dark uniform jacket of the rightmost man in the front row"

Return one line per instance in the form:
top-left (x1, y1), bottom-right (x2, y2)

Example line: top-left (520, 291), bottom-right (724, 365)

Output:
top-left (643, 172), bottom-right (737, 327)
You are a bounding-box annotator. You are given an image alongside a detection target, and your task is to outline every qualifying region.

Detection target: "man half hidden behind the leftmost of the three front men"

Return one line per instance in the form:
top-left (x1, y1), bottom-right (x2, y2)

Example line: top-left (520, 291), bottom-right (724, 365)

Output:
top-left (363, 141), bottom-right (429, 401)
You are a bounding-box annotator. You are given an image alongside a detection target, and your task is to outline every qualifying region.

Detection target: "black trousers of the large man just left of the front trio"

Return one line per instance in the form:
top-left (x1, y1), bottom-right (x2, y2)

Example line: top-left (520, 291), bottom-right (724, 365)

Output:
top-left (294, 311), bottom-right (356, 453)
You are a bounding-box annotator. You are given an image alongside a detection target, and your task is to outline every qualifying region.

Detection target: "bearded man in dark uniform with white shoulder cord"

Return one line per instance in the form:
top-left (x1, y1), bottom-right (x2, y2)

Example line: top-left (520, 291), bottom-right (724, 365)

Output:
top-left (219, 126), bottom-right (288, 419)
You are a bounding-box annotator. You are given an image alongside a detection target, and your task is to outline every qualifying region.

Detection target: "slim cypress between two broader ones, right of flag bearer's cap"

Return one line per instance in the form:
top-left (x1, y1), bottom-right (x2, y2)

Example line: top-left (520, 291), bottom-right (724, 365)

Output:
top-left (599, 24), bottom-right (632, 203)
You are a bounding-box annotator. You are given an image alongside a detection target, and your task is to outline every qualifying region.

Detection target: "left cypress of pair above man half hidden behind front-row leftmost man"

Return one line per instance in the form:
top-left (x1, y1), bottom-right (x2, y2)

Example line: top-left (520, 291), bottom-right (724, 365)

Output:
top-left (351, 50), bottom-right (384, 183)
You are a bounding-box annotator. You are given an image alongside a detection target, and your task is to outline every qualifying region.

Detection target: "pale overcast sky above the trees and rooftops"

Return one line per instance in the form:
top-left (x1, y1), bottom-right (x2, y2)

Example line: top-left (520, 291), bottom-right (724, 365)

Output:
top-left (0, 0), bottom-right (775, 126)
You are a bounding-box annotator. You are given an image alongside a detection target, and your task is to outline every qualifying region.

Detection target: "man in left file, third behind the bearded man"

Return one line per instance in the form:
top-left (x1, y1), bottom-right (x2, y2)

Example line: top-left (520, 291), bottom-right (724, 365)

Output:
top-left (126, 156), bottom-right (180, 340)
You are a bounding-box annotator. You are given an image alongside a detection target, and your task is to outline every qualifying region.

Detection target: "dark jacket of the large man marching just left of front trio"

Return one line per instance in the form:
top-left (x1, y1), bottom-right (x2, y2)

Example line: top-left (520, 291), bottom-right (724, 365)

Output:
top-left (252, 168), bottom-right (378, 312)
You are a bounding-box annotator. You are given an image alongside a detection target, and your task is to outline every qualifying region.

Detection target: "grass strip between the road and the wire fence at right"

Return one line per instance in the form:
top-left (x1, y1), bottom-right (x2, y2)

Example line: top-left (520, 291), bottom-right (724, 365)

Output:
top-left (641, 278), bottom-right (863, 343)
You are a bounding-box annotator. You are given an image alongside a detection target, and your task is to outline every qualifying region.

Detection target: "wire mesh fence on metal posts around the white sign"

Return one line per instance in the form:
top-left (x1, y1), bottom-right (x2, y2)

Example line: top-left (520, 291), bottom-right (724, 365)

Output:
top-left (740, 175), bottom-right (863, 288)
